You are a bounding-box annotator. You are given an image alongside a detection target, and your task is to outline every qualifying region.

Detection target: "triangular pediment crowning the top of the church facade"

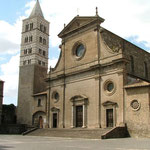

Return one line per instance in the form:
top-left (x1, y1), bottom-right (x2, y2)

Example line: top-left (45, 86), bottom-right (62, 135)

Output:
top-left (58, 16), bottom-right (104, 38)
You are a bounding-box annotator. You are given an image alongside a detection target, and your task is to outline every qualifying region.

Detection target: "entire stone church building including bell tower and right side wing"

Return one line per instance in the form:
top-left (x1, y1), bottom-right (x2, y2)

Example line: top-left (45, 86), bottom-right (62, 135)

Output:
top-left (18, 1), bottom-right (150, 135)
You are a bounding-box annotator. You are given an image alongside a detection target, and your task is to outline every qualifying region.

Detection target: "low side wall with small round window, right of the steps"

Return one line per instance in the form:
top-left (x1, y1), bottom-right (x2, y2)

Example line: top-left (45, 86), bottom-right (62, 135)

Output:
top-left (125, 86), bottom-right (150, 137)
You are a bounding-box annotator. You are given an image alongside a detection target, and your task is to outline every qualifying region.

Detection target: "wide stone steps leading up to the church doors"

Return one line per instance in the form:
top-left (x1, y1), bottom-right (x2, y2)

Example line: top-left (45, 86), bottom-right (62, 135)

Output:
top-left (28, 128), bottom-right (110, 139)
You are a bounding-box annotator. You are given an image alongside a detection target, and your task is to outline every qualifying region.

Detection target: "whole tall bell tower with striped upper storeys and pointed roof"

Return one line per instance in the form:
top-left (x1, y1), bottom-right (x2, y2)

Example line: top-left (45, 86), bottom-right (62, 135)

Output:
top-left (17, 0), bottom-right (49, 125)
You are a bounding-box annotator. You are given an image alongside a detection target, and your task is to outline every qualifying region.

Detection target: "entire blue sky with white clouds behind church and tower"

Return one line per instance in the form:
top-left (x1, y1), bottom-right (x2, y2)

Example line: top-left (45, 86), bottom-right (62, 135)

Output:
top-left (0, 0), bottom-right (150, 105)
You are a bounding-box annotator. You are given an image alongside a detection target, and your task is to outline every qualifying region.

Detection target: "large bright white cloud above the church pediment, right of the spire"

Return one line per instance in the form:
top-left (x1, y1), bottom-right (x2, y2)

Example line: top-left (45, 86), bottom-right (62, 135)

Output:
top-left (38, 0), bottom-right (150, 47)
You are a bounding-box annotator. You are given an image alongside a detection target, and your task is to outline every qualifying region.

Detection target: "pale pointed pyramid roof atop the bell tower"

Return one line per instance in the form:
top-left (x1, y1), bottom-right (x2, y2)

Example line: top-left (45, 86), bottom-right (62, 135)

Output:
top-left (29, 0), bottom-right (44, 18)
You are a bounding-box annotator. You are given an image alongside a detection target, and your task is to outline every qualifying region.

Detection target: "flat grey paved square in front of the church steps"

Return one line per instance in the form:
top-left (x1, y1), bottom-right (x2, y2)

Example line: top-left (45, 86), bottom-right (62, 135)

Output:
top-left (0, 135), bottom-right (150, 150)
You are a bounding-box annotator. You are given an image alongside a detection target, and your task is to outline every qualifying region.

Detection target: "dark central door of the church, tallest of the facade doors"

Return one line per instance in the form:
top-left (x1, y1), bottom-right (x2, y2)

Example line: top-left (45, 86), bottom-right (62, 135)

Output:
top-left (76, 106), bottom-right (83, 127)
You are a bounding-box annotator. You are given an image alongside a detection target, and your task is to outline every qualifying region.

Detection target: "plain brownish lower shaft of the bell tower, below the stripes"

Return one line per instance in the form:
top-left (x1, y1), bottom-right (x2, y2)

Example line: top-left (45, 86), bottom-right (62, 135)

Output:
top-left (17, 65), bottom-right (47, 125)
